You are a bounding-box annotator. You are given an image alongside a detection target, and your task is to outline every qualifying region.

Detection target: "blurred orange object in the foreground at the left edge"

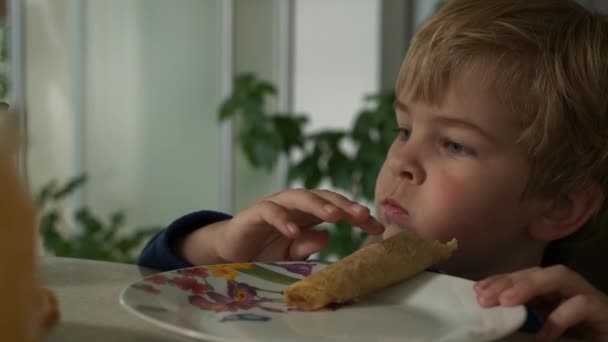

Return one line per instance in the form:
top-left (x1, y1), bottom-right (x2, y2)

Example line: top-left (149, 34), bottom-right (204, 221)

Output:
top-left (0, 111), bottom-right (59, 342)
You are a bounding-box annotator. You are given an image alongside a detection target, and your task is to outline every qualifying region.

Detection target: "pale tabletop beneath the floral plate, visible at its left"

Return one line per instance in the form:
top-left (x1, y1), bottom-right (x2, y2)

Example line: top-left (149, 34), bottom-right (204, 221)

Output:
top-left (40, 257), bottom-right (566, 342)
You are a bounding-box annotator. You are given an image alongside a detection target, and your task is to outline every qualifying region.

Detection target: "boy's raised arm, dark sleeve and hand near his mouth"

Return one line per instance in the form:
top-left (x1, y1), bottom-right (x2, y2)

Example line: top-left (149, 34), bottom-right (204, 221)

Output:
top-left (139, 189), bottom-right (384, 270)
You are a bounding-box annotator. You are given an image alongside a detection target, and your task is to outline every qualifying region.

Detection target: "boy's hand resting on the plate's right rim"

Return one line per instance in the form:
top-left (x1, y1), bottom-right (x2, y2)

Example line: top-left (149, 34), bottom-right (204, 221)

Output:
top-left (475, 265), bottom-right (608, 341)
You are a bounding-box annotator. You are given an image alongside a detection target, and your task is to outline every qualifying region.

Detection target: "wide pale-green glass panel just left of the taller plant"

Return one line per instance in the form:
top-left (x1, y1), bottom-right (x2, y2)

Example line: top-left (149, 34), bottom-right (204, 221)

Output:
top-left (85, 0), bottom-right (222, 228)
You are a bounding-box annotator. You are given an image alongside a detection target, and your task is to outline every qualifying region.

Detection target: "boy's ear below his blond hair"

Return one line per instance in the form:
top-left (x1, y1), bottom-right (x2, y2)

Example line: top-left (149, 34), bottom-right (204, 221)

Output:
top-left (528, 183), bottom-right (604, 242)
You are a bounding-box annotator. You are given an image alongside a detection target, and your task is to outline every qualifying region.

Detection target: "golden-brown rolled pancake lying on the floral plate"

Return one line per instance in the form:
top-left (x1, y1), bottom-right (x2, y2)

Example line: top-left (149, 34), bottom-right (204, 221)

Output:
top-left (285, 231), bottom-right (458, 310)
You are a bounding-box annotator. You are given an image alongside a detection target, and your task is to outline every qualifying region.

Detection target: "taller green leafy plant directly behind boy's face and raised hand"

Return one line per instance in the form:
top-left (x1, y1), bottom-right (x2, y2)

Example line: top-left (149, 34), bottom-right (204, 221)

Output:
top-left (219, 73), bottom-right (396, 259)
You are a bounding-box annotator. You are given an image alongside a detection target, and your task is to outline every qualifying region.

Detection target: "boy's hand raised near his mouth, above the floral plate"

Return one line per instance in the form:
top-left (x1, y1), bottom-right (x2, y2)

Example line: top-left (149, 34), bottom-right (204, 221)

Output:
top-left (183, 189), bottom-right (384, 264)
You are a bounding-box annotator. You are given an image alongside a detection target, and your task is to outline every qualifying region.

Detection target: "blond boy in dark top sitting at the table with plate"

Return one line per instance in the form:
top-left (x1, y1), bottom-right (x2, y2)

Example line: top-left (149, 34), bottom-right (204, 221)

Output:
top-left (140, 0), bottom-right (608, 340)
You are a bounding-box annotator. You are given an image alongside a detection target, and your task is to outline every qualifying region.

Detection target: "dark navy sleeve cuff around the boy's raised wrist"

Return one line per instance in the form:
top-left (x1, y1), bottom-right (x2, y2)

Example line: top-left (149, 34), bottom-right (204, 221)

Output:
top-left (137, 210), bottom-right (232, 271)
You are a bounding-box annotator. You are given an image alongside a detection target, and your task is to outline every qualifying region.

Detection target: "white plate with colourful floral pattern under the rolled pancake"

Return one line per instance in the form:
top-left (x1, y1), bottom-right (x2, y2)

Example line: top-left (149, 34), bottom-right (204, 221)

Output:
top-left (121, 262), bottom-right (526, 342)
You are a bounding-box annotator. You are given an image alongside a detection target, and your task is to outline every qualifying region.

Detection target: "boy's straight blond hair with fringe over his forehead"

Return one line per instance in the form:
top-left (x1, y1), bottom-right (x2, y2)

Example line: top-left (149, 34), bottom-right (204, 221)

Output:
top-left (397, 0), bottom-right (608, 289)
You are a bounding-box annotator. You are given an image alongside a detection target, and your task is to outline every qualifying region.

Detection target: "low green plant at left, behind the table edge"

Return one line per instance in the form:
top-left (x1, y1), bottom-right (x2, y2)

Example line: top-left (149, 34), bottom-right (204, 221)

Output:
top-left (36, 175), bottom-right (161, 263)
